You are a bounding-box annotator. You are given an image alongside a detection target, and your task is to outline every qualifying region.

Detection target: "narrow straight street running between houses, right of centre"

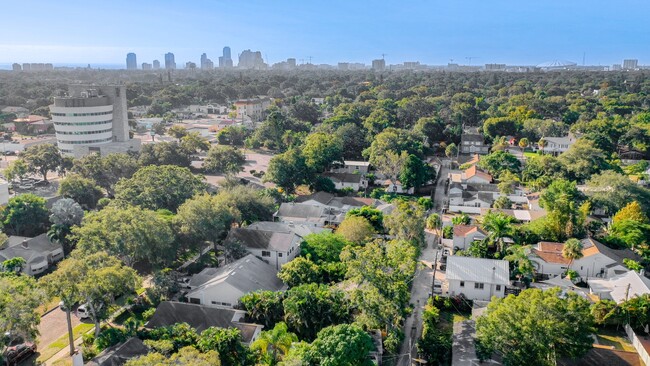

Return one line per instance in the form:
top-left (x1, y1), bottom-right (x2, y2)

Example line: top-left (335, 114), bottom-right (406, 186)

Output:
top-left (397, 159), bottom-right (450, 366)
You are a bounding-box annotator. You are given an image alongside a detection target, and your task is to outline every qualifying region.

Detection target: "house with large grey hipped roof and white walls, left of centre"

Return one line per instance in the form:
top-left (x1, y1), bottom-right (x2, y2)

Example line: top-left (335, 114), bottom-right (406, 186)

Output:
top-left (186, 254), bottom-right (284, 308)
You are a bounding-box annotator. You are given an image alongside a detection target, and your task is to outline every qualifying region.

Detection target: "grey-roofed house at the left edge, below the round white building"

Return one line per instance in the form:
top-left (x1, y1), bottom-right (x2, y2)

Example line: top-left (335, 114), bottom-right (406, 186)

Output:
top-left (0, 234), bottom-right (63, 276)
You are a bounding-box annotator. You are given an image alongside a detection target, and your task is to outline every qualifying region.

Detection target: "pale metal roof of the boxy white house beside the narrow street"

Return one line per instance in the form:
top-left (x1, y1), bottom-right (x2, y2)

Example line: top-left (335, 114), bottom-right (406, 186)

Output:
top-left (447, 255), bottom-right (510, 285)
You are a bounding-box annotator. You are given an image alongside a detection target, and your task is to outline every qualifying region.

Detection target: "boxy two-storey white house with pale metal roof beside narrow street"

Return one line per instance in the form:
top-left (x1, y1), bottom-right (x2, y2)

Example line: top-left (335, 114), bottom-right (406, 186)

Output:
top-left (447, 255), bottom-right (510, 301)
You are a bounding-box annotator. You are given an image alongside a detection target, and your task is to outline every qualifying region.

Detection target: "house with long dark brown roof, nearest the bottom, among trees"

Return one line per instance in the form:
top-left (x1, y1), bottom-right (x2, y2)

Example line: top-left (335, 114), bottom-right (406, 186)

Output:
top-left (145, 301), bottom-right (263, 345)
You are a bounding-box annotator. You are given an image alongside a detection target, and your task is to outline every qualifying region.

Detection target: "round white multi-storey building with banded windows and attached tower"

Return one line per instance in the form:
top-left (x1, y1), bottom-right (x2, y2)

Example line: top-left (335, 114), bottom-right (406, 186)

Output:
top-left (50, 85), bottom-right (140, 157)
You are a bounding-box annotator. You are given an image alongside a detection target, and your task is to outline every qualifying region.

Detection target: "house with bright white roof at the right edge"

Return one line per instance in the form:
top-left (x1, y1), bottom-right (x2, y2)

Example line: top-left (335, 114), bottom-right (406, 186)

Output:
top-left (587, 271), bottom-right (650, 304)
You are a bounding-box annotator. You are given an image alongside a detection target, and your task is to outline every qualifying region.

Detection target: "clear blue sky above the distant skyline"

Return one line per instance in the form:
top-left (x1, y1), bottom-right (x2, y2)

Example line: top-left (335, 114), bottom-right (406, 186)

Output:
top-left (0, 0), bottom-right (650, 66)
